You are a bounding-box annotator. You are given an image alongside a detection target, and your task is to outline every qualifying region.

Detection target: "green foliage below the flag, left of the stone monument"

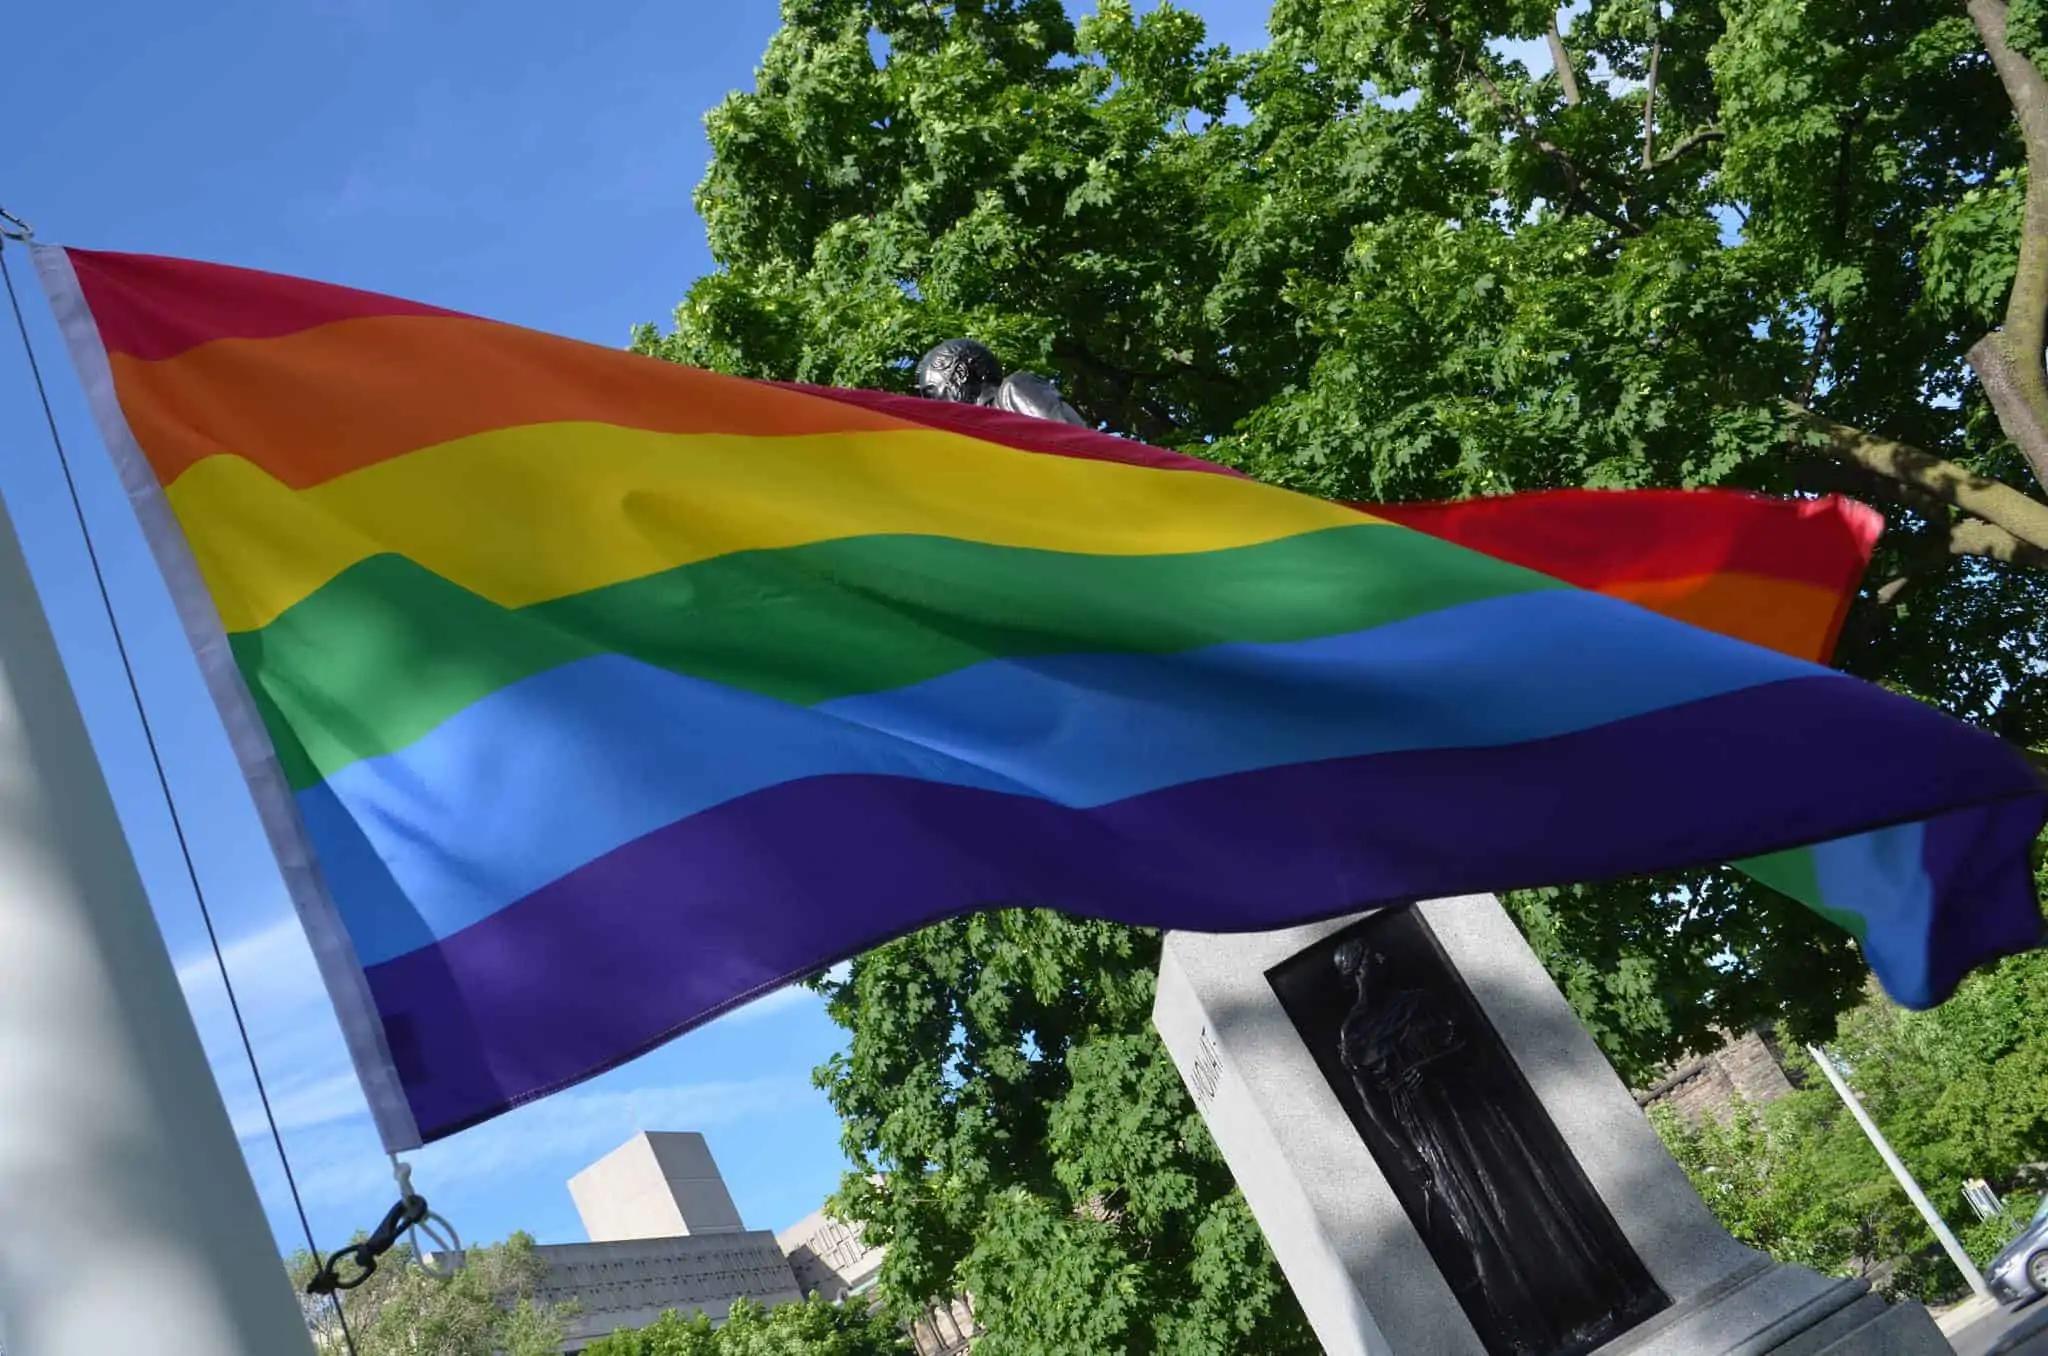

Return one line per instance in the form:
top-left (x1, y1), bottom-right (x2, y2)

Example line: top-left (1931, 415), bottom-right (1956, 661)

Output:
top-left (802, 909), bottom-right (1313, 1354)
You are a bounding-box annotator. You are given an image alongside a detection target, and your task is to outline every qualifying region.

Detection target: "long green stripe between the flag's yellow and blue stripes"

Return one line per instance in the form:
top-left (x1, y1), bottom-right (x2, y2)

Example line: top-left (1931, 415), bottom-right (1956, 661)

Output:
top-left (231, 524), bottom-right (1563, 789)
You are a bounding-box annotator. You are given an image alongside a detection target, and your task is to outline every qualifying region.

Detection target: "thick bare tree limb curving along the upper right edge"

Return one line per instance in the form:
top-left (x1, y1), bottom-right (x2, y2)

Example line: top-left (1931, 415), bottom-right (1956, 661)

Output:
top-left (1968, 0), bottom-right (2048, 497)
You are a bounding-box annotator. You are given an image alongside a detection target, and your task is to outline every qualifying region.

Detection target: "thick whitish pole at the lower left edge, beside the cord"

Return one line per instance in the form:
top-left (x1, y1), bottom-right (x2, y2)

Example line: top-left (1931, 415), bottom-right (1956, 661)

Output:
top-left (0, 477), bottom-right (313, 1356)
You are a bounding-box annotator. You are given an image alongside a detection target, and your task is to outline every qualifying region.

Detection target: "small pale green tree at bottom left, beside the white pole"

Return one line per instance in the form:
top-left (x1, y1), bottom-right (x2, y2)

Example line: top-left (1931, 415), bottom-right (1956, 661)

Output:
top-left (285, 1233), bottom-right (575, 1356)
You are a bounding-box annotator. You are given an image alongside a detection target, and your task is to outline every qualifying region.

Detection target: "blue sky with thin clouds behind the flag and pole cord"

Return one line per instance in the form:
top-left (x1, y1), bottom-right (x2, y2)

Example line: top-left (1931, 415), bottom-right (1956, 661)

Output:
top-left (0, 0), bottom-right (1266, 1247)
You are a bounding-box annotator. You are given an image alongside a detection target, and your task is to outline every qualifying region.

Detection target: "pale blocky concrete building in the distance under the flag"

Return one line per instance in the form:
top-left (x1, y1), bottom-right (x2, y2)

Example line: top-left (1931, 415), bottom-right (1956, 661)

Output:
top-left (535, 1133), bottom-right (803, 1352)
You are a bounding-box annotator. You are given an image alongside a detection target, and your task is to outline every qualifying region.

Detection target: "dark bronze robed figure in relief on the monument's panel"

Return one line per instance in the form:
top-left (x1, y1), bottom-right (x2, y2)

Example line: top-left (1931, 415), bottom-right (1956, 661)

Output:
top-left (1333, 938), bottom-right (1624, 1356)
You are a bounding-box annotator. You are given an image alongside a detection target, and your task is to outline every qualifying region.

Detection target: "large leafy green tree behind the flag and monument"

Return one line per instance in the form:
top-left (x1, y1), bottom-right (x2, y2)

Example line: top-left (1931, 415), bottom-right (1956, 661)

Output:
top-left (635, 0), bottom-right (2048, 1352)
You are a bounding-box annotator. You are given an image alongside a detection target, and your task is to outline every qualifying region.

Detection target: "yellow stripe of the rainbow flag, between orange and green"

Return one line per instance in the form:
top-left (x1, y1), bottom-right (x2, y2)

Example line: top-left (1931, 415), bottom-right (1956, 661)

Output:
top-left (168, 424), bottom-right (1372, 631)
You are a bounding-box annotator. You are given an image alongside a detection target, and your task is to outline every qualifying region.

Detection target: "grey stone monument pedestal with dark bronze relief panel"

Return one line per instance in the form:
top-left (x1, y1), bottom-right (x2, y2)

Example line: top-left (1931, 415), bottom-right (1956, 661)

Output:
top-left (1153, 895), bottom-right (1950, 1356)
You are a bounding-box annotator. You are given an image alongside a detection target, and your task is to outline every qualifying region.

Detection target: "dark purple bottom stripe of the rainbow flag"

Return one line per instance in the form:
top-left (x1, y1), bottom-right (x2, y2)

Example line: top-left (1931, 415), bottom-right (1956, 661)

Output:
top-left (369, 676), bottom-right (2048, 1139)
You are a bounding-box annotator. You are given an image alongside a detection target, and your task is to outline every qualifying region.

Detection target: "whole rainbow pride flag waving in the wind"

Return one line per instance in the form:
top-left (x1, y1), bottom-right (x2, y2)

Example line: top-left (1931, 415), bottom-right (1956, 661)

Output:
top-left (37, 248), bottom-right (2048, 1149)
